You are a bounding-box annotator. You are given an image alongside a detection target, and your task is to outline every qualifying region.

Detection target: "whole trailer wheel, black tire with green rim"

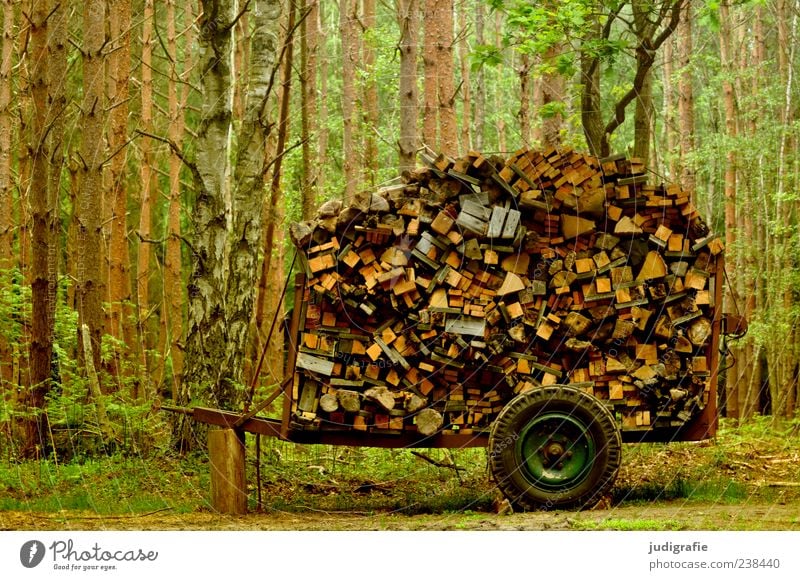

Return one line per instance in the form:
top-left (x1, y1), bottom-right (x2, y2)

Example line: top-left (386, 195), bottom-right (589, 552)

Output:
top-left (489, 385), bottom-right (622, 510)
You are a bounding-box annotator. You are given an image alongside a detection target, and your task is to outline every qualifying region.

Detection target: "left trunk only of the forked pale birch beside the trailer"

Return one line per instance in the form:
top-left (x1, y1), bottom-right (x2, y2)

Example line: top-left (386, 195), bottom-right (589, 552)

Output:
top-left (184, 0), bottom-right (236, 426)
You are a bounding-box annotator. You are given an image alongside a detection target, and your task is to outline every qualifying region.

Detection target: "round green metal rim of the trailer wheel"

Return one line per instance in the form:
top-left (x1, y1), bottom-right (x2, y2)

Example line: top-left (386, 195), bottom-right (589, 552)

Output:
top-left (516, 412), bottom-right (595, 491)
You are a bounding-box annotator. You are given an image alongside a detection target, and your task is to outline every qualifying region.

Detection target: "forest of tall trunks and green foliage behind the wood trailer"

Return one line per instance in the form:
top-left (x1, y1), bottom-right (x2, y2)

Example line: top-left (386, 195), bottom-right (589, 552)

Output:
top-left (0, 0), bottom-right (800, 520)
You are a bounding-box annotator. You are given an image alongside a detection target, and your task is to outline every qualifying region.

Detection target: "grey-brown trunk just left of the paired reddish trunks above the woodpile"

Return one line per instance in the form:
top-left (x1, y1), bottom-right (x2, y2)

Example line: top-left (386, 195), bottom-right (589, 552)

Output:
top-left (397, 0), bottom-right (419, 173)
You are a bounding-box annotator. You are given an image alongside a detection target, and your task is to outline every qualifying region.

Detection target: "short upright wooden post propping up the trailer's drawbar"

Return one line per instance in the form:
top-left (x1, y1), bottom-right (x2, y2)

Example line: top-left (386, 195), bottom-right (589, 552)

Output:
top-left (208, 429), bottom-right (247, 515)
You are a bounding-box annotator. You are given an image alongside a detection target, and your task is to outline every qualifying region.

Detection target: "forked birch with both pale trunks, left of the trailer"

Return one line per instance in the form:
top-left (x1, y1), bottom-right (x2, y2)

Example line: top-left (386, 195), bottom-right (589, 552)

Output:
top-left (179, 0), bottom-right (280, 439)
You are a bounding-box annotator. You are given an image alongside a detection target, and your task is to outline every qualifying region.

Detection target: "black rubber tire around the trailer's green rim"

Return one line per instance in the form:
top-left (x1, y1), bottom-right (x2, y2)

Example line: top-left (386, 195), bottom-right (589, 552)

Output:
top-left (489, 385), bottom-right (622, 511)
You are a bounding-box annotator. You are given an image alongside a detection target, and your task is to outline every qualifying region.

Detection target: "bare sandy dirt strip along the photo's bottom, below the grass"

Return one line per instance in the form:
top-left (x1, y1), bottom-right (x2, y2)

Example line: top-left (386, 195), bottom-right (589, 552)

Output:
top-left (0, 501), bottom-right (800, 531)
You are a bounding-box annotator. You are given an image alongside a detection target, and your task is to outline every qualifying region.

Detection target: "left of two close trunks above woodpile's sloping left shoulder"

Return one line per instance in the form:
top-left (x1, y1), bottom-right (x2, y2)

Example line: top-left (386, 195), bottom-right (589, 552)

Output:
top-left (339, 0), bottom-right (359, 200)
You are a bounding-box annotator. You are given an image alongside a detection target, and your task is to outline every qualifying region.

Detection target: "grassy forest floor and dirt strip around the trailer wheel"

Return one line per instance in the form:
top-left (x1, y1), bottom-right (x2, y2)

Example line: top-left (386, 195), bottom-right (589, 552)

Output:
top-left (0, 421), bottom-right (800, 530)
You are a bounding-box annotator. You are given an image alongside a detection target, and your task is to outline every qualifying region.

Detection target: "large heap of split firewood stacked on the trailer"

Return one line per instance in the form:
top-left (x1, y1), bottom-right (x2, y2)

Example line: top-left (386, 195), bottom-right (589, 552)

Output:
top-left (291, 149), bottom-right (723, 435)
